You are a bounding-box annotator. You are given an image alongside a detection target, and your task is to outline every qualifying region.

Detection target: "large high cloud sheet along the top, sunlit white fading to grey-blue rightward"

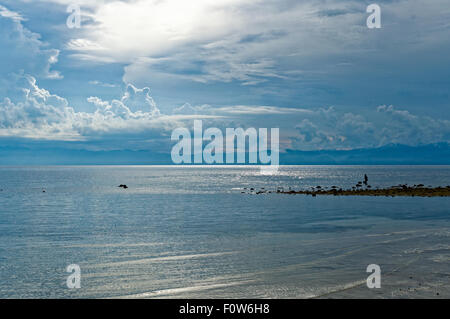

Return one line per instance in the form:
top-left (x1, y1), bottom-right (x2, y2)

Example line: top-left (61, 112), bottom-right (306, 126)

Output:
top-left (59, 0), bottom-right (450, 85)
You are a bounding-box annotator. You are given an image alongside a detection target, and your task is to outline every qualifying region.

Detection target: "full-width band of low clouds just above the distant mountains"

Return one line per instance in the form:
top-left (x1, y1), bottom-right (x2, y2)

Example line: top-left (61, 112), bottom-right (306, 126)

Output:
top-left (0, 75), bottom-right (450, 150)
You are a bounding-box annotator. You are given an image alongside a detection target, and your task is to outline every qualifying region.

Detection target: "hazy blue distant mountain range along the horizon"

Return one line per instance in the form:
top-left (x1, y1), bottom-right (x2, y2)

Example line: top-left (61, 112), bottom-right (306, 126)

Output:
top-left (0, 143), bottom-right (450, 166)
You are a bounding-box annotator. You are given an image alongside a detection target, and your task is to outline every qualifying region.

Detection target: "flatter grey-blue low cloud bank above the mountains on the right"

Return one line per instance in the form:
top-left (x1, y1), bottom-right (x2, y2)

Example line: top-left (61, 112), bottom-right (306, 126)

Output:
top-left (170, 103), bottom-right (450, 151)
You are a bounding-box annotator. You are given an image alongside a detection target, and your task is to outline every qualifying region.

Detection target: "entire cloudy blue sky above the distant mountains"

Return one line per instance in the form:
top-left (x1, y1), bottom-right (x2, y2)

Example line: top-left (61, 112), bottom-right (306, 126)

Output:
top-left (0, 0), bottom-right (450, 164)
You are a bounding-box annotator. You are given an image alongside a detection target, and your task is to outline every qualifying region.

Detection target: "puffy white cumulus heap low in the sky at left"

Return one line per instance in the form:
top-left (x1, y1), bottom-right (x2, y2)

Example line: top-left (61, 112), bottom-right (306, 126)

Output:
top-left (0, 75), bottom-right (174, 140)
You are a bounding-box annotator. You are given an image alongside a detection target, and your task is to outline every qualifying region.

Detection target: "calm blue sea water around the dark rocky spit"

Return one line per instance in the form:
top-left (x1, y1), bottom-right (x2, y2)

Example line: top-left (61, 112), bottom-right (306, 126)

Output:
top-left (0, 166), bottom-right (450, 298)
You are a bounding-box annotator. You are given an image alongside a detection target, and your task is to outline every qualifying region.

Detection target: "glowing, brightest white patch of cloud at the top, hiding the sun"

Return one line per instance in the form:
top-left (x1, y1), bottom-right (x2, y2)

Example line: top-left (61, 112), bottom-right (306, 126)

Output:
top-left (68, 0), bottom-right (250, 62)
